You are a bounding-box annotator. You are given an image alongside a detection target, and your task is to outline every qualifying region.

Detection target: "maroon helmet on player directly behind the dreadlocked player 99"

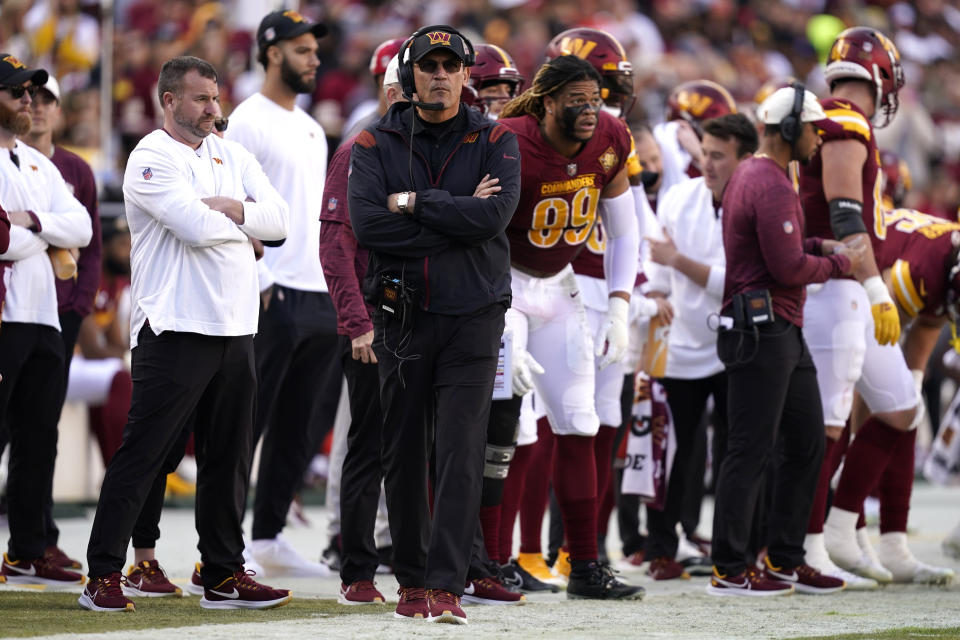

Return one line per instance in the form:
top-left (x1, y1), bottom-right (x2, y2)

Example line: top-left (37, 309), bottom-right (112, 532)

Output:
top-left (547, 27), bottom-right (636, 118)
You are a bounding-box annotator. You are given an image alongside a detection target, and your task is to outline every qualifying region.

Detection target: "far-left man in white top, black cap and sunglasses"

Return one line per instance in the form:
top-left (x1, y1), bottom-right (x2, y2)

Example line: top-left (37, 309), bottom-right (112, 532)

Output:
top-left (0, 53), bottom-right (92, 585)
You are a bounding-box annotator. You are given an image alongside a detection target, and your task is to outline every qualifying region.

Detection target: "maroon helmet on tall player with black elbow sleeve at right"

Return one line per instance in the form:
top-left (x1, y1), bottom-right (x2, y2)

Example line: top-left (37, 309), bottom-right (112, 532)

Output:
top-left (824, 27), bottom-right (903, 128)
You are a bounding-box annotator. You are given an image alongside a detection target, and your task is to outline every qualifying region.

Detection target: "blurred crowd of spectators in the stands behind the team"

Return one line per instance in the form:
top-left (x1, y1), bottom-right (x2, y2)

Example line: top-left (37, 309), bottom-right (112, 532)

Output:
top-left (0, 0), bottom-right (960, 218)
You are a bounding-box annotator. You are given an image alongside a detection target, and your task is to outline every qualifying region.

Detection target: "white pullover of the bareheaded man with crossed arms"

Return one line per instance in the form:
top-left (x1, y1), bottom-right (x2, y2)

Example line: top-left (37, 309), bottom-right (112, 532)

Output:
top-left (123, 129), bottom-right (289, 348)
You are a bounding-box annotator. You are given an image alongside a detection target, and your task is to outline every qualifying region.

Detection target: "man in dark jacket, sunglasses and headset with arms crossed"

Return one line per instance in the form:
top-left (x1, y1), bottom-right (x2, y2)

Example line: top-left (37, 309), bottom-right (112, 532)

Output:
top-left (348, 25), bottom-right (520, 623)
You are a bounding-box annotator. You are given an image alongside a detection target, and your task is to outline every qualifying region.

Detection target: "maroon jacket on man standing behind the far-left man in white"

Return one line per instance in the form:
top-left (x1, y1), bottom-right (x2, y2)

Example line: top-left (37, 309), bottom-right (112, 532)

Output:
top-left (50, 147), bottom-right (102, 317)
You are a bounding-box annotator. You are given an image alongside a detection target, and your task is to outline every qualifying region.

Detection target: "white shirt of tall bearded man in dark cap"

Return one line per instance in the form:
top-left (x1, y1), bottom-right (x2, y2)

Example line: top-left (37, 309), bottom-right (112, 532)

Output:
top-left (226, 93), bottom-right (328, 291)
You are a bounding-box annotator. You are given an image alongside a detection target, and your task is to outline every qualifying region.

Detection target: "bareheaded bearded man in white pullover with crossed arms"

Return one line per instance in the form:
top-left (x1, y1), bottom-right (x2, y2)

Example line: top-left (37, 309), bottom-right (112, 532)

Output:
top-left (80, 56), bottom-right (290, 611)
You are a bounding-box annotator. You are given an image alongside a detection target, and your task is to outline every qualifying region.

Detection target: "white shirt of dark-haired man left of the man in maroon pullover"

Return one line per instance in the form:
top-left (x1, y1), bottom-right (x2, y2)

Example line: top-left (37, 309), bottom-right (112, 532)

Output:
top-left (644, 178), bottom-right (726, 380)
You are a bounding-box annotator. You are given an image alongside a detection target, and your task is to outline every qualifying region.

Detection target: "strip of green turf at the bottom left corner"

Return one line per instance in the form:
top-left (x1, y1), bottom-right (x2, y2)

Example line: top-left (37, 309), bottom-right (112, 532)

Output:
top-left (0, 591), bottom-right (382, 638)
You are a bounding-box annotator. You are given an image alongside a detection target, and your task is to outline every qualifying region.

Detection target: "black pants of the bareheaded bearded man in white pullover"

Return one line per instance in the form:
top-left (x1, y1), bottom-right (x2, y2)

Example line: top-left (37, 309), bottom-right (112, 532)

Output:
top-left (87, 326), bottom-right (257, 587)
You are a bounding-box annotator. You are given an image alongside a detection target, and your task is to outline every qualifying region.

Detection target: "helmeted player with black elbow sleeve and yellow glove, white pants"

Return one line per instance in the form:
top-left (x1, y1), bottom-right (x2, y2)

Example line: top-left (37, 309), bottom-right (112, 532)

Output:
top-left (800, 27), bottom-right (927, 588)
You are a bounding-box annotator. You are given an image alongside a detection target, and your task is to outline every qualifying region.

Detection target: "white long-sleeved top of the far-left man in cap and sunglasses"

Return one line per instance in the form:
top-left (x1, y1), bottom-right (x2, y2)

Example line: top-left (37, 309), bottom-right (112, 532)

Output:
top-left (0, 140), bottom-right (92, 331)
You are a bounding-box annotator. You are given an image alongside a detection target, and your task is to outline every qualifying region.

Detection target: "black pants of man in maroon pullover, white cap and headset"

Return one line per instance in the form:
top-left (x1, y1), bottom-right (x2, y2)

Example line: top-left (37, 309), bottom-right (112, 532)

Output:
top-left (712, 319), bottom-right (824, 574)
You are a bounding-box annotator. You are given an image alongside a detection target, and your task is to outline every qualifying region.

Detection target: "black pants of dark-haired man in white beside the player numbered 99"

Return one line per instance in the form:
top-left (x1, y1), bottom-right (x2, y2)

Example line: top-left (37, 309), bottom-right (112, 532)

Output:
top-left (646, 372), bottom-right (727, 560)
